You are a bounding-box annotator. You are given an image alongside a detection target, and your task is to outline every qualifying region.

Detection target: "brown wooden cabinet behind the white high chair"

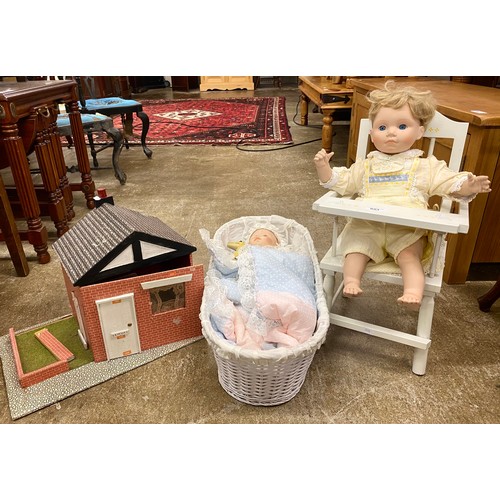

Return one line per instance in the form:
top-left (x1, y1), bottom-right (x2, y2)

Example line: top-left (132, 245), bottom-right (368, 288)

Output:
top-left (347, 78), bottom-right (500, 284)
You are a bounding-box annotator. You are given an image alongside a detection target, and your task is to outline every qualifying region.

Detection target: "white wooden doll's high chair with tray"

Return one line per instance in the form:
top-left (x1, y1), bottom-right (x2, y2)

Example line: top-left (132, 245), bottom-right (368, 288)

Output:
top-left (313, 112), bottom-right (469, 375)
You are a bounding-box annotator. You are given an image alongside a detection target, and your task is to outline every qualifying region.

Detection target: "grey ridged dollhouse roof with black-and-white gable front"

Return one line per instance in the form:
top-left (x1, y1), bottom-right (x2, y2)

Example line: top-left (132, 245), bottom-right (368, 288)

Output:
top-left (53, 203), bottom-right (196, 286)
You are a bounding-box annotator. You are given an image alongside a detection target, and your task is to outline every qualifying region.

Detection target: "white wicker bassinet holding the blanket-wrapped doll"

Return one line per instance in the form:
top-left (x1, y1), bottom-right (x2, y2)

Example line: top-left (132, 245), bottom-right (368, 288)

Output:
top-left (200, 215), bottom-right (330, 406)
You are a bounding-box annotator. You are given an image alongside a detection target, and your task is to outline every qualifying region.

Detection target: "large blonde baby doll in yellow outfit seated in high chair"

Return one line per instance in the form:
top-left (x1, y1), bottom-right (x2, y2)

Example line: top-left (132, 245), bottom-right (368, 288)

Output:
top-left (314, 82), bottom-right (491, 310)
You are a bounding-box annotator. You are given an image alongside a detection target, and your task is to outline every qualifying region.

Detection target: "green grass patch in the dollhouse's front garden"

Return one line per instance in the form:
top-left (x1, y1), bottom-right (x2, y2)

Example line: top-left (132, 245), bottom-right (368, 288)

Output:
top-left (16, 316), bottom-right (94, 373)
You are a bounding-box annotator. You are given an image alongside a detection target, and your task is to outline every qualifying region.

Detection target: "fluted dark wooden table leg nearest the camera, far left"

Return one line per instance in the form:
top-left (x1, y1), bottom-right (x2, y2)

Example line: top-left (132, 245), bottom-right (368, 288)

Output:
top-left (2, 124), bottom-right (50, 264)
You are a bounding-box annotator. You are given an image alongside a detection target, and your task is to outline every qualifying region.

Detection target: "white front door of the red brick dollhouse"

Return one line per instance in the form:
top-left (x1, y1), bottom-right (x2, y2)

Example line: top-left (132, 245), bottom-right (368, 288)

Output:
top-left (96, 293), bottom-right (141, 359)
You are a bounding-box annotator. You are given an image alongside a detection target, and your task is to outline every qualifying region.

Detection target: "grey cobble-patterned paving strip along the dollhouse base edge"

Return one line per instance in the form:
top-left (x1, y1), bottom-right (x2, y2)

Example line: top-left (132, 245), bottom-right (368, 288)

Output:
top-left (0, 314), bottom-right (203, 420)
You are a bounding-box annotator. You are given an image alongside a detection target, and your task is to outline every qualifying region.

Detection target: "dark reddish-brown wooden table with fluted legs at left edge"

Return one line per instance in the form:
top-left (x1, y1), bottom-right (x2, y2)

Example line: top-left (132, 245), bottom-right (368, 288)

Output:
top-left (0, 80), bottom-right (95, 264)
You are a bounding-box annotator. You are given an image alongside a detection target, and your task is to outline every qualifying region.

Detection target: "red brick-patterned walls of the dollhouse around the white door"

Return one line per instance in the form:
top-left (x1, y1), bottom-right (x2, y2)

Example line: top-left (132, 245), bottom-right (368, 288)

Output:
top-left (65, 265), bottom-right (204, 362)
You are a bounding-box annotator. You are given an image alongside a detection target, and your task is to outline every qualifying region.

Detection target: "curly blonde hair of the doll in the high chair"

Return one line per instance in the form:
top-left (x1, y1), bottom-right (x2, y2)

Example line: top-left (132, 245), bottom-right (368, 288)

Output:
top-left (366, 80), bottom-right (436, 127)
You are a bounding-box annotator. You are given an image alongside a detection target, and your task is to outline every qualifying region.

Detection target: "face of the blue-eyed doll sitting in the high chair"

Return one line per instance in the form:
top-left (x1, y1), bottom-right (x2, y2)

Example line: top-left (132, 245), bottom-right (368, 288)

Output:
top-left (370, 104), bottom-right (425, 154)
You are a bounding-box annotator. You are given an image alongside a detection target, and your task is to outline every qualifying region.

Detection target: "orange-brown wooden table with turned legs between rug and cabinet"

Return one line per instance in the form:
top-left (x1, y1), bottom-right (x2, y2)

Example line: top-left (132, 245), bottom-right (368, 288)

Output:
top-left (299, 76), bottom-right (353, 153)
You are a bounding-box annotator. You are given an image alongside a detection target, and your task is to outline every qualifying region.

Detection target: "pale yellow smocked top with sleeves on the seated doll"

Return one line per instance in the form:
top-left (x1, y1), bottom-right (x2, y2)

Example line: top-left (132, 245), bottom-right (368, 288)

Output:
top-left (320, 149), bottom-right (475, 208)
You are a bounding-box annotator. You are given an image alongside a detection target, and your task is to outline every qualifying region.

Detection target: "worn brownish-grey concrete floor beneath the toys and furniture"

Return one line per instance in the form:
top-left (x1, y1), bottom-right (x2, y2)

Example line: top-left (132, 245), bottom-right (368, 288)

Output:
top-left (0, 83), bottom-right (500, 424)
